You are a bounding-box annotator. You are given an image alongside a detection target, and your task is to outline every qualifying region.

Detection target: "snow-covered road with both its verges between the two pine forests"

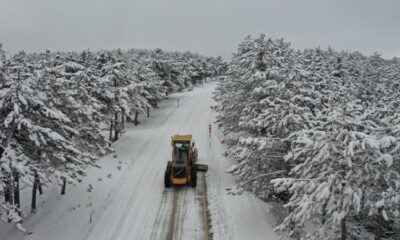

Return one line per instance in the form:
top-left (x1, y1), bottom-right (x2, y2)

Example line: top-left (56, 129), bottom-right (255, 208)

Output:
top-left (0, 84), bottom-right (278, 240)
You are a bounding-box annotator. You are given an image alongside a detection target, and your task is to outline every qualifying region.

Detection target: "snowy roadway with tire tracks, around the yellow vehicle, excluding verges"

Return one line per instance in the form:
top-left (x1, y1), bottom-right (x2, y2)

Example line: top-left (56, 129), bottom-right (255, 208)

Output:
top-left (85, 85), bottom-right (208, 240)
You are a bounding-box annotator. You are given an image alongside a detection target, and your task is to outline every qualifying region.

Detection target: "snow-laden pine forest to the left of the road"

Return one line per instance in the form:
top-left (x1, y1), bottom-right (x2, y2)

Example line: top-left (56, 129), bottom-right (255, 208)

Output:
top-left (0, 45), bottom-right (227, 227)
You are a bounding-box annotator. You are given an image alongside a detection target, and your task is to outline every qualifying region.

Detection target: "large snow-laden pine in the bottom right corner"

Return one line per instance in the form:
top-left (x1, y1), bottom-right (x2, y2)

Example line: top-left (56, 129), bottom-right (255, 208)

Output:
top-left (273, 98), bottom-right (400, 239)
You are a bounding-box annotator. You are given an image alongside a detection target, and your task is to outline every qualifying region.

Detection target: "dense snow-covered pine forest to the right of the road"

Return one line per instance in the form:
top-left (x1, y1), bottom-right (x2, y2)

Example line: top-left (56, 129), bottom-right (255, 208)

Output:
top-left (215, 35), bottom-right (400, 240)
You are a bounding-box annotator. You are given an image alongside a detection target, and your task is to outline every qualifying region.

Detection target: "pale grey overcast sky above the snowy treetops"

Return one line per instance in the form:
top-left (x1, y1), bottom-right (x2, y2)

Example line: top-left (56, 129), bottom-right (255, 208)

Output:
top-left (0, 0), bottom-right (400, 59)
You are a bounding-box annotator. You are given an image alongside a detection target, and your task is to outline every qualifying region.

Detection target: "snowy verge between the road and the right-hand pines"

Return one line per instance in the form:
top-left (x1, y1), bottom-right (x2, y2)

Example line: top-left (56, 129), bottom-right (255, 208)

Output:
top-left (207, 99), bottom-right (286, 240)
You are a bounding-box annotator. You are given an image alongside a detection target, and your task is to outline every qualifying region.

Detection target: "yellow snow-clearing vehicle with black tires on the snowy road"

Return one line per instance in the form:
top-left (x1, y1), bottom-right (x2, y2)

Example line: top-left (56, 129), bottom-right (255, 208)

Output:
top-left (164, 135), bottom-right (208, 188)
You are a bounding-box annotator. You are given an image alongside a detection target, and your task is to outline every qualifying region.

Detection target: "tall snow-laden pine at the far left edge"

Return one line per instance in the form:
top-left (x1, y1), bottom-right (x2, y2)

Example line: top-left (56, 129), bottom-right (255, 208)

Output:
top-left (0, 52), bottom-right (61, 218)
